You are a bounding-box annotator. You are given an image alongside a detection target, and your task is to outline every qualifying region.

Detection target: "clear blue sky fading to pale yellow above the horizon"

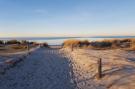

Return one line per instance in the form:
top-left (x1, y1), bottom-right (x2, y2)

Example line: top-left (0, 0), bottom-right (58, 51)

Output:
top-left (0, 0), bottom-right (135, 37)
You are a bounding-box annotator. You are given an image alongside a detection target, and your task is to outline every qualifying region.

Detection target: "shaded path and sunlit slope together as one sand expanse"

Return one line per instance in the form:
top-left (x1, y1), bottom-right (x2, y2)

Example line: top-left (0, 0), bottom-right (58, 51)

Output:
top-left (0, 48), bottom-right (135, 89)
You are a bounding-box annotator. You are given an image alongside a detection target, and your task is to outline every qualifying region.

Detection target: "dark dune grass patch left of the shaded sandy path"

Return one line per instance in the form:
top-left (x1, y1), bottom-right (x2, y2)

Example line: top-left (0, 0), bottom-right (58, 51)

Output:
top-left (0, 40), bottom-right (37, 53)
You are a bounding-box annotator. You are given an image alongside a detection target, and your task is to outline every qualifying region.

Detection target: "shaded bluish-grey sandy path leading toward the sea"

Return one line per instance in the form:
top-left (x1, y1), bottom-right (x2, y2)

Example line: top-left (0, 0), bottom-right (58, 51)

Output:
top-left (0, 49), bottom-right (75, 89)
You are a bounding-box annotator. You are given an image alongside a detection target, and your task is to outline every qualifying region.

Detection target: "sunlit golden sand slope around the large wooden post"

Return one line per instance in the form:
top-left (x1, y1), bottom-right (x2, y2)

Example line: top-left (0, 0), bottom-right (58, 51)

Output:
top-left (61, 49), bottom-right (135, 89)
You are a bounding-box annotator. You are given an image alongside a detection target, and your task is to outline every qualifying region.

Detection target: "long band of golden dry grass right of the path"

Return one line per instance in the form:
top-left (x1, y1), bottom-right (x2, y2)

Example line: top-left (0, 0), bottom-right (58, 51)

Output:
top-left (63, 38), bottom-right (135, 50)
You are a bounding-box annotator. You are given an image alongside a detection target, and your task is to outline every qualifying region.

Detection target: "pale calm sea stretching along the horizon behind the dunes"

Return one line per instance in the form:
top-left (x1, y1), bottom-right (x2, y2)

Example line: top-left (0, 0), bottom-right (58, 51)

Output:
top-left (0, 36), bottom-right (135, 45)
